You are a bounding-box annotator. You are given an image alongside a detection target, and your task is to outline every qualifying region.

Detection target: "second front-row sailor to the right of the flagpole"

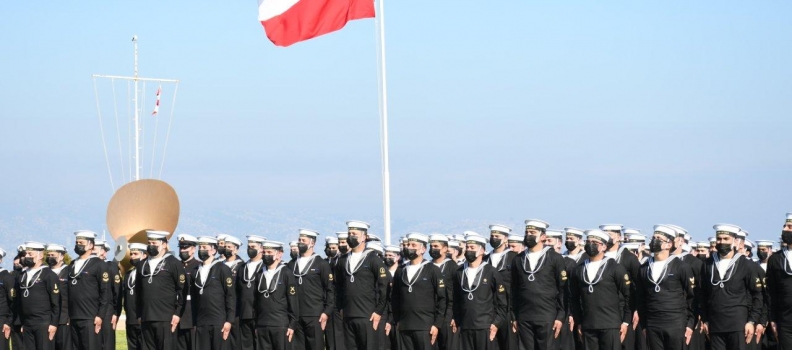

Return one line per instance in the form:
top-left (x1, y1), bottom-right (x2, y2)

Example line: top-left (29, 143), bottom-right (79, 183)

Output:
top-left (451, 233), bottom-right (508, 350)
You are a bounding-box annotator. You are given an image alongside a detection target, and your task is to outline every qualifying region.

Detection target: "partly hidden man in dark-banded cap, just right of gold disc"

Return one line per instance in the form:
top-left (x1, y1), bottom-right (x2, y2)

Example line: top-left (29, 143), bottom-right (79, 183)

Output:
top-left (176, 234), bottom-right (201, 350)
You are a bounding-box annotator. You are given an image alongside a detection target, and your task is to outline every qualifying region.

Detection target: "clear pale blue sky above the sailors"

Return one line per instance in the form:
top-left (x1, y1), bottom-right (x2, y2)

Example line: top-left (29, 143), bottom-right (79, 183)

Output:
top-left (0, 0), bottom-right (792, 246)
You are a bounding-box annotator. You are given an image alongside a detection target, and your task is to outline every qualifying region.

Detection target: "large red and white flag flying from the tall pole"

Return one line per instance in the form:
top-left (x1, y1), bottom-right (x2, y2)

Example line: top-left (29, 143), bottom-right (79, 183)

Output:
top-left (258, 0), bottom-right (374, 46)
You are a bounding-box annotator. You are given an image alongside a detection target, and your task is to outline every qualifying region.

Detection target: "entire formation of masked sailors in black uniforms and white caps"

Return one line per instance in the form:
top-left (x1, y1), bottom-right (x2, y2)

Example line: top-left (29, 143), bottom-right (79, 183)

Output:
top-left (0, 213), bottom-right (792, 350)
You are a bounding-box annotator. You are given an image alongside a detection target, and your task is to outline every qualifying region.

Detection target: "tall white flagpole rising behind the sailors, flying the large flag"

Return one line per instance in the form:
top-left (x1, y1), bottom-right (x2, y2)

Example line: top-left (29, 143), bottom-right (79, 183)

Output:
top-left (379, 0), bottom-right (391, 244)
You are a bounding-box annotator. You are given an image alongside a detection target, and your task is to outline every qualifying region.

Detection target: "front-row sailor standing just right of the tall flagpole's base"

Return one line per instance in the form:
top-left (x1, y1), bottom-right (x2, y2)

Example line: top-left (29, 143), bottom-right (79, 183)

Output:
top-left (391, 232), bottom-right (448, 350)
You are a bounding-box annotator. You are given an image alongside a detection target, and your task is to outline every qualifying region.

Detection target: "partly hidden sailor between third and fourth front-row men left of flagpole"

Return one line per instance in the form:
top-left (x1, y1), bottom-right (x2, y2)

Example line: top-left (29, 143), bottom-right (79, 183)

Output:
top-left (236, 235), bottom-right (266, 350)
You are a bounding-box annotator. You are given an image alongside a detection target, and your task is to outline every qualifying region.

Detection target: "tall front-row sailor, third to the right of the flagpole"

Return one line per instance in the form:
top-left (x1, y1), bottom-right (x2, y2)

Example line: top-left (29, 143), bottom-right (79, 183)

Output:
top-left (511, 219), bottom-right (568, 350)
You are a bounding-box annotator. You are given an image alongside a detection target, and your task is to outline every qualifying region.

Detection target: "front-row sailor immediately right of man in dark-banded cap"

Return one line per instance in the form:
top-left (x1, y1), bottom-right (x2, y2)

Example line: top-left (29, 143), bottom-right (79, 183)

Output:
top-left (190, 237), bottom-right (236, 350)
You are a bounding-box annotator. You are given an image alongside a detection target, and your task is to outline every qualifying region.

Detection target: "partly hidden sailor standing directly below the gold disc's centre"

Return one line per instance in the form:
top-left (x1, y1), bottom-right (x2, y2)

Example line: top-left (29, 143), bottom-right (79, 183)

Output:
top-left (121, 243), bottom-right (147, 350)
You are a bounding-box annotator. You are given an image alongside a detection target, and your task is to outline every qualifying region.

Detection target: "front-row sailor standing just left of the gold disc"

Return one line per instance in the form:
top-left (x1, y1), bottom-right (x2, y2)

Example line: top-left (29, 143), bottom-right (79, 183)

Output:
top-left (69, 231), bottom-right (112, 350)
